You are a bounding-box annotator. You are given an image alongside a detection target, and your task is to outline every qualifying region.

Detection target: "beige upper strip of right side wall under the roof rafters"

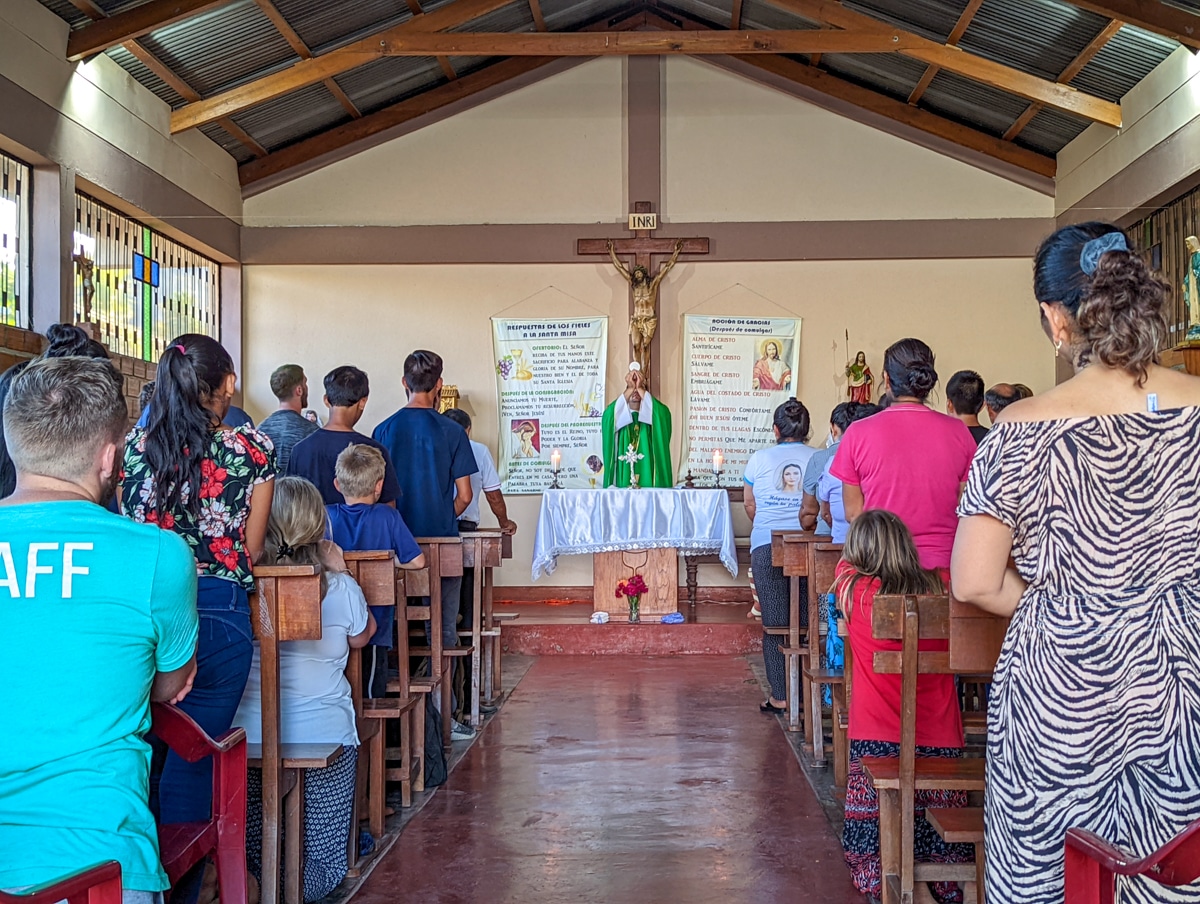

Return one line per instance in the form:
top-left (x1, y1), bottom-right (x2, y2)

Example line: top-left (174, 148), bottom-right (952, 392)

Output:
top-left (1055, 47), bottom-right (1200, 220)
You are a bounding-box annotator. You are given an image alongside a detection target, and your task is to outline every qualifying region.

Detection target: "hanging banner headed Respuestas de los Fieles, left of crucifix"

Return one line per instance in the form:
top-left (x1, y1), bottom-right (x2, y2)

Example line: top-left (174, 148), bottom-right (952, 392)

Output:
top-left (492, 317), bottom-right (608, 496)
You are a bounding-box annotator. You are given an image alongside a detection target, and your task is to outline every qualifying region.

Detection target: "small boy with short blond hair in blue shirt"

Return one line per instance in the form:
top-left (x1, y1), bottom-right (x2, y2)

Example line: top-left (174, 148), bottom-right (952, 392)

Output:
top-left (325, 443), bottom-right (425, 698)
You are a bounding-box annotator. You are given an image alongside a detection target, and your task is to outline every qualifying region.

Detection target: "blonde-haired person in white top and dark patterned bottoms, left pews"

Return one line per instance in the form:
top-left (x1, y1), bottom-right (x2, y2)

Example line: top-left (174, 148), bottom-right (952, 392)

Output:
top-left (234, 477), bottom-right (376, 902)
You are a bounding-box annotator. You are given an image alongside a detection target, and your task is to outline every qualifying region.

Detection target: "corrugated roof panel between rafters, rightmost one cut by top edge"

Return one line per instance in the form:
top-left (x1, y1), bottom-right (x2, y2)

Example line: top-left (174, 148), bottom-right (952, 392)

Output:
top-left (959, 0), bottom-right (1109, 80)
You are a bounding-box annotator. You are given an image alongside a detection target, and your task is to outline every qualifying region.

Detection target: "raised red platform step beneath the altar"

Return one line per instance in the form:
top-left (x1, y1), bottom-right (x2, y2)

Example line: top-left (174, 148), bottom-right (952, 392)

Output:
top-left (494, 602), bottom-right (762, 655)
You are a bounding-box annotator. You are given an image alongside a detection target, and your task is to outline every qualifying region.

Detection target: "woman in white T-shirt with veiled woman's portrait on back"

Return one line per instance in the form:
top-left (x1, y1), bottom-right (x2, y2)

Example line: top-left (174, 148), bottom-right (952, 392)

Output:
top-left (743, 399), bottom-right (817, 713)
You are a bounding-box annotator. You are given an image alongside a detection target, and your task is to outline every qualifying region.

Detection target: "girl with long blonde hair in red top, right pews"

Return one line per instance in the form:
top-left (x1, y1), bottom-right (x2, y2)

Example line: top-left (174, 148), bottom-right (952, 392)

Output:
top-left (833, 509), bottom-right (974, 904)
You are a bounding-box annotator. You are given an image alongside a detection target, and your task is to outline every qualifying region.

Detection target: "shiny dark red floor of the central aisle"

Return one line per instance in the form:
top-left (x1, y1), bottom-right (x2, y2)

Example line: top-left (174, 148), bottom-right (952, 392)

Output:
top-left (355, 655), bottom-right (863, 904)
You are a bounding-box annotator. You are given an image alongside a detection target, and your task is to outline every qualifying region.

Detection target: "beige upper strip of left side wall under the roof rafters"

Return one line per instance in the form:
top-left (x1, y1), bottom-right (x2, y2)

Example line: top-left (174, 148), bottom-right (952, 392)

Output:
top-left (0, 0), bottom-right (241, 217)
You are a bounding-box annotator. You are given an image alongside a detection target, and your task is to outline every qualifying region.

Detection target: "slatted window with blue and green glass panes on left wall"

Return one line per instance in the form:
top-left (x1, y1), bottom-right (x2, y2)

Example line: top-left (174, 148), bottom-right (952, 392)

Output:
top-left (73, 192), bottom-right (221, 361)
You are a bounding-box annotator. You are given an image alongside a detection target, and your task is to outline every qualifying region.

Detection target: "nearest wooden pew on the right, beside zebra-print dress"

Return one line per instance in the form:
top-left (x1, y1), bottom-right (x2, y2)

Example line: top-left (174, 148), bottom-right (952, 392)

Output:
top-left (862, 594), bottom-right (1007, 904)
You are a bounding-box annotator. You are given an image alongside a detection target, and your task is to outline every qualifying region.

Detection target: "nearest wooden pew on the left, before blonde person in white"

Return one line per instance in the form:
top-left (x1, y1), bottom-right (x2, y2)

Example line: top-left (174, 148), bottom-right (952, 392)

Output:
top-left (246, 565), bottom-right (342, 904)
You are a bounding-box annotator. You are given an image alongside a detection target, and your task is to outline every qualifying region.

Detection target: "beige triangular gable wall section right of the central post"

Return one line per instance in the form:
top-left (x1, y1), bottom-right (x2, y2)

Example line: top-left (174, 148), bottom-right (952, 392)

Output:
top-left (662, 56), bottom-right (1054, 223)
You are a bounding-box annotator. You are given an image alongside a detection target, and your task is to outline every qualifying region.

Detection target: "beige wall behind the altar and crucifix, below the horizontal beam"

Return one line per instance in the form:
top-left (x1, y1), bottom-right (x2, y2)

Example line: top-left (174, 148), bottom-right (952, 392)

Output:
top-left (241, 261), bottom-right (1054, 586)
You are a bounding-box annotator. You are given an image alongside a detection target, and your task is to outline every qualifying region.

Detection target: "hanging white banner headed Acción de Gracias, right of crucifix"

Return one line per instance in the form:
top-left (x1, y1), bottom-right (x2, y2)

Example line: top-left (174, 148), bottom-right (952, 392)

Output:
top-left (679, 315), bottom-right (800, 486)
